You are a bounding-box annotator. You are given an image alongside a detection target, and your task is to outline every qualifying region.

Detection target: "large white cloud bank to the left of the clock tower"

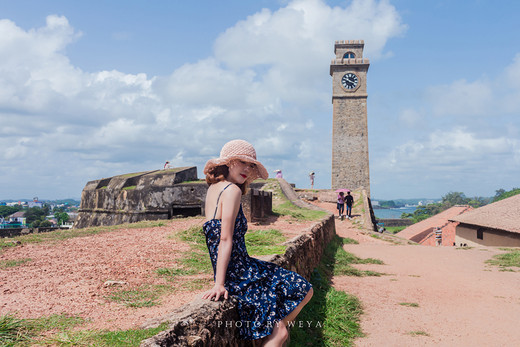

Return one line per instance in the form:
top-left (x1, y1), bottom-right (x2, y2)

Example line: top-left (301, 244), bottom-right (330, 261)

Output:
top-left (0, 0), bottom-right (405, 197)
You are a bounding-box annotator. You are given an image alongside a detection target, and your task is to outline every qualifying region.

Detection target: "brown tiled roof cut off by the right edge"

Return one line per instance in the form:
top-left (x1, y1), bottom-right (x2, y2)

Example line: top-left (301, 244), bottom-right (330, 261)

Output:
top-left (452, 194), bottom-right (520, 233)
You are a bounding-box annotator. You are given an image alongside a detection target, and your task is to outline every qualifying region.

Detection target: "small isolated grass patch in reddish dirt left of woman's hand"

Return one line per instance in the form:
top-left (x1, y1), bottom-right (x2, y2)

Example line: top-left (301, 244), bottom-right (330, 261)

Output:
top-left (107, 285), bottom-right (172, 308)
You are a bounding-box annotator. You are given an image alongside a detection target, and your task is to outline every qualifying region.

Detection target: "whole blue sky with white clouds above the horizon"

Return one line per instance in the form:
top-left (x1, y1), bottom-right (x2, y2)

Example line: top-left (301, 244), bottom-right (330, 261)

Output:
top-left (0, 0), bottom-right (520, 199)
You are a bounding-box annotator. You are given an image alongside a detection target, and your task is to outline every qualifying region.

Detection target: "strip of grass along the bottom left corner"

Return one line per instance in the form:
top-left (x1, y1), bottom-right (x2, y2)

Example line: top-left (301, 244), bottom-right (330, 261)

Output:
top-left (0, 314), bottom-right (166, 347)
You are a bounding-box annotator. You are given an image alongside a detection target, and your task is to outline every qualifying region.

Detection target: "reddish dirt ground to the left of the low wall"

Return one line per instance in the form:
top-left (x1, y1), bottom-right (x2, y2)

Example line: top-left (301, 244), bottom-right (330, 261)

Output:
top-left (0, 217), bottom-right (311, 330)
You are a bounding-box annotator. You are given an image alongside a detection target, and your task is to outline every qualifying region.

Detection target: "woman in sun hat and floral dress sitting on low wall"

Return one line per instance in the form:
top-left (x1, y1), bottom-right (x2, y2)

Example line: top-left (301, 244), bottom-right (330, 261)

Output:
top-left (202, 140), bottom-right (313, 346)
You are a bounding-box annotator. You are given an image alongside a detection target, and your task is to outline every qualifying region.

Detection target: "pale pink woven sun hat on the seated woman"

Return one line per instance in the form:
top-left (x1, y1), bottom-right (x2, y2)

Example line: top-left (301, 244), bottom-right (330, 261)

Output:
top-left (204, 140), bottom-right (269, 180)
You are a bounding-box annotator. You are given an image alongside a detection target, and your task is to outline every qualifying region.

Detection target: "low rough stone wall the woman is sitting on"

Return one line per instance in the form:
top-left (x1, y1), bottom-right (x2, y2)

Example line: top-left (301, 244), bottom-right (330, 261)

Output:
top-left (141, 180), bottom-right (335, 347)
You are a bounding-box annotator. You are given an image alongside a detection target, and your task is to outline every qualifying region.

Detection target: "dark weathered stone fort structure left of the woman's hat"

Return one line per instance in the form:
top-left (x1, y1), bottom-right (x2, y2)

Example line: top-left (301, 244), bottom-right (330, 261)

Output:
top-left (74, 167), bottom-right (207, 228)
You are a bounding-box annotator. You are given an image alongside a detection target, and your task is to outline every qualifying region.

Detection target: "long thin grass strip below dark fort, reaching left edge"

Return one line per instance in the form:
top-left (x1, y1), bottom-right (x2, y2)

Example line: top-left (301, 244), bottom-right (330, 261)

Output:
top-left (0, 221), bottom-right (167, 249)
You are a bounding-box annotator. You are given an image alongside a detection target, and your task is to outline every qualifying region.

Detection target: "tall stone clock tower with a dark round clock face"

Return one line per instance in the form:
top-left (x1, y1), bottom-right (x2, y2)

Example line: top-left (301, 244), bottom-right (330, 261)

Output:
top-left (330, 40), bottom-right (370, 196)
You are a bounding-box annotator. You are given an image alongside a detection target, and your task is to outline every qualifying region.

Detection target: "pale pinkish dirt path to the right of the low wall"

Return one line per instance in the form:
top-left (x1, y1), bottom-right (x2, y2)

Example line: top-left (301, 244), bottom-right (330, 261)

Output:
top-left (314, 204), bottom-right (520, 347)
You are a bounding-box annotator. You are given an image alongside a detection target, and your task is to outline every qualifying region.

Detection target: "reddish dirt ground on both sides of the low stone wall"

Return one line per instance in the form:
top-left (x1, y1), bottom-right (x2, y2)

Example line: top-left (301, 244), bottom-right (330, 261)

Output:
top-left (0, 203), bottom-right (520, 346)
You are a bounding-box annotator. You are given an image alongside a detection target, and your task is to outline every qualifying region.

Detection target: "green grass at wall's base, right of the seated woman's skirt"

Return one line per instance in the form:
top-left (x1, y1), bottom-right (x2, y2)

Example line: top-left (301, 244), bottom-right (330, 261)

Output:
top-left (289, 236), bottom-right (363, 347)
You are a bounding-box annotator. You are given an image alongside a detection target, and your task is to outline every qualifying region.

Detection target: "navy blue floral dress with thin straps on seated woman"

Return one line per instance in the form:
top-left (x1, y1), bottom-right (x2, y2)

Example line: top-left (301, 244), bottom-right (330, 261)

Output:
top-left (203, 185), bottom-right (312, 340)
